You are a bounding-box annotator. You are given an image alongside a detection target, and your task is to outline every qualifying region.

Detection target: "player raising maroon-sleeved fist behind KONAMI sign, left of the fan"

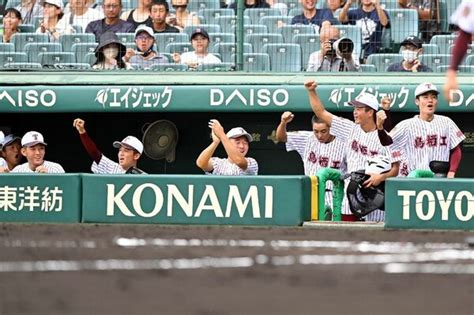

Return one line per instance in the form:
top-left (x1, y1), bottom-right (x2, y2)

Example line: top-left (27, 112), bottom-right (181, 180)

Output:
top-left (73, 118), bottom-right (143, 174)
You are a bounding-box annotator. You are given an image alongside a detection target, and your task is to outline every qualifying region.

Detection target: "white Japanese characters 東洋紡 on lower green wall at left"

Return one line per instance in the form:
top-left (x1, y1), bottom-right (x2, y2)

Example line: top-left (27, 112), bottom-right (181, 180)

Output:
top-left (0, 186), bottom-right (63, 212)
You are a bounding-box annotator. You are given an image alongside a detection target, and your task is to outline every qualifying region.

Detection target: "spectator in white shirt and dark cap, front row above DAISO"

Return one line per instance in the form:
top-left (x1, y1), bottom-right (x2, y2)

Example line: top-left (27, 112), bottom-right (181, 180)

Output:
top-left (173, 27), bottom-right (221, 69)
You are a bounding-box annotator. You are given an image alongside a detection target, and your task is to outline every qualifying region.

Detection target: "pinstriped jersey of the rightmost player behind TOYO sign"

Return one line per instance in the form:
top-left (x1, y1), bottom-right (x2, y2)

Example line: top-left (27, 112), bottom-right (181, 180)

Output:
top-left (390, 115), bottom-right (466, 172)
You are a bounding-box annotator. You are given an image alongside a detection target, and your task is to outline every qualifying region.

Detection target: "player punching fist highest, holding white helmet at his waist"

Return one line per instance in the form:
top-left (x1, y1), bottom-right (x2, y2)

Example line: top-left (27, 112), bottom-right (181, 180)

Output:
top-left (304, 81), bottom-right (400, 221)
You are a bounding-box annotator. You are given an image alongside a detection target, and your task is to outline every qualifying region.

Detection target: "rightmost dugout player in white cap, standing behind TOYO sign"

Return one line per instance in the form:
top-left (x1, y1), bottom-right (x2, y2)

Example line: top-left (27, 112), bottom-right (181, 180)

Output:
top-left (377, 83), bottom-right (466, 178)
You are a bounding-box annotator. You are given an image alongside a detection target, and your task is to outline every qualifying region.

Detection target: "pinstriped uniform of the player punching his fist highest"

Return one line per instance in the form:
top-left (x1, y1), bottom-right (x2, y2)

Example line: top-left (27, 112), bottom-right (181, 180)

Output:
top-left (331, 115), bottom-right (401, 222)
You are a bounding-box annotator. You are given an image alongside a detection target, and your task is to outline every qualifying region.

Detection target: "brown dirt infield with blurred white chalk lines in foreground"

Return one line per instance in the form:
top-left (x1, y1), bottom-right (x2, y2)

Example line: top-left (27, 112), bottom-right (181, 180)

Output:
top-left (0, 224), bottom-right (474, 315)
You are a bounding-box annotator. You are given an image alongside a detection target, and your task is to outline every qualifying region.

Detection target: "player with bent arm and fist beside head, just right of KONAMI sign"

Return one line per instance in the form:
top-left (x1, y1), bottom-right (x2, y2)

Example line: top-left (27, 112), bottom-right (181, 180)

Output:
top-left (276, 112), bottom-right (345, 210)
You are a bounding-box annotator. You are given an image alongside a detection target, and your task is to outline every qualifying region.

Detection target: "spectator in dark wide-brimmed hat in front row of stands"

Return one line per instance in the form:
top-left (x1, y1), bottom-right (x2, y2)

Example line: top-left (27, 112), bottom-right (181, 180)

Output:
top-left (92, 31), bottom-right (130, 70)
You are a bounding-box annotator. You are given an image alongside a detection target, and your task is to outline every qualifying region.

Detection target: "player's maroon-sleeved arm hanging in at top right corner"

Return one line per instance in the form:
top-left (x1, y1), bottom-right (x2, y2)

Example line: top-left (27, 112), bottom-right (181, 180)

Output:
top-left (444, 0), bottom-right (474, 102)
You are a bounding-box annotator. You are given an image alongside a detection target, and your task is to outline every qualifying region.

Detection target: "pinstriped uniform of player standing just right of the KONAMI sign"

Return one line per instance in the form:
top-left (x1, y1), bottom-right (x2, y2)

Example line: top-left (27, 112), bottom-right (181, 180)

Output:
top-left (286, 131), bottom-right (345, 210)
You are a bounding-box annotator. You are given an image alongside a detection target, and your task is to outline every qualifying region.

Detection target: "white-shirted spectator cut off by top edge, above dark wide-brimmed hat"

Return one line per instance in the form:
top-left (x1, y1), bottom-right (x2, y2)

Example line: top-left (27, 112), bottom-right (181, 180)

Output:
top-left (56, 0), bottom-right (104, 35)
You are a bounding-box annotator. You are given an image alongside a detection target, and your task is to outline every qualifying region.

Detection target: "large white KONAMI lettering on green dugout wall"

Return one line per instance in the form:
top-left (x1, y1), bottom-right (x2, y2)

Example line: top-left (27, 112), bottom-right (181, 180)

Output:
top-left (106, 183), bottom-right (273, 219)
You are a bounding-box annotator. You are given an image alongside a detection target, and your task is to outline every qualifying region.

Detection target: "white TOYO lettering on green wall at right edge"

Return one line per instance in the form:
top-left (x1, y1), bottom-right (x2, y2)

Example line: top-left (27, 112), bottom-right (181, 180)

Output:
top-left (397, 190), bottom-right (474, 222)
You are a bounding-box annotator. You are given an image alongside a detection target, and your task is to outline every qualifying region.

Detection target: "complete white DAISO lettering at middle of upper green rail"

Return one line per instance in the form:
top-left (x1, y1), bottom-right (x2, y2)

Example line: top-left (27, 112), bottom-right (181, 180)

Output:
top-left (209, 89), bottom-right (289, 107)
